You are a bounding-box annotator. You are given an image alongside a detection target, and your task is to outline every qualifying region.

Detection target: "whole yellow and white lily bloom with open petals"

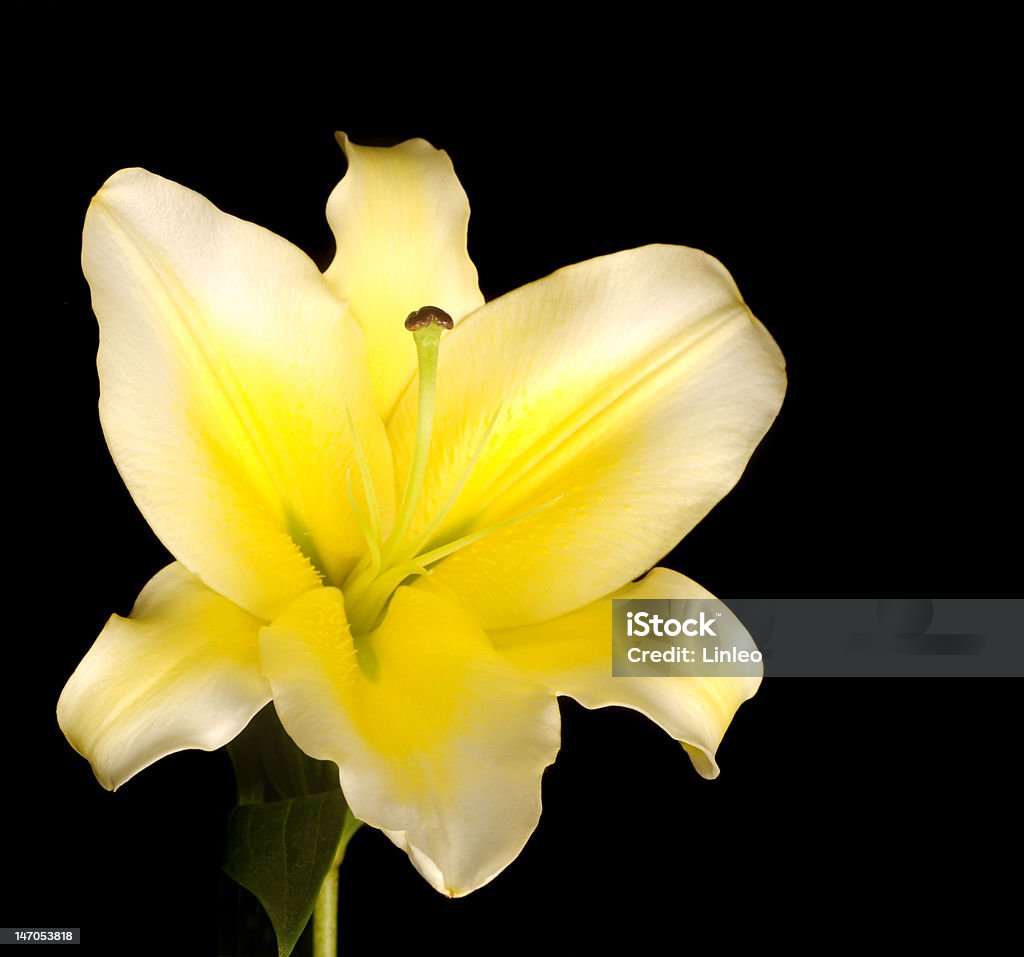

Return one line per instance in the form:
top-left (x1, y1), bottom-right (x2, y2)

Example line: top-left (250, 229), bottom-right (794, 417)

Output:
top-left (57, 137), bottom-right (785, 896)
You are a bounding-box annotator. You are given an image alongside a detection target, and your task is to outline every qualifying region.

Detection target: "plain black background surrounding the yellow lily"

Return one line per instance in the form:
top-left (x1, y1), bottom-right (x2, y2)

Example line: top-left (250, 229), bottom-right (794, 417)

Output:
top-left (8, 39), bottom-right (1021, 955)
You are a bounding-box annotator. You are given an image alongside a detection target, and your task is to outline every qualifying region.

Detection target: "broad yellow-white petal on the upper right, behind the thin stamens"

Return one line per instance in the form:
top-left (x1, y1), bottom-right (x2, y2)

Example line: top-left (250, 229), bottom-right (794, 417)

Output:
top-left (388, 246), bottom-right (785, 628)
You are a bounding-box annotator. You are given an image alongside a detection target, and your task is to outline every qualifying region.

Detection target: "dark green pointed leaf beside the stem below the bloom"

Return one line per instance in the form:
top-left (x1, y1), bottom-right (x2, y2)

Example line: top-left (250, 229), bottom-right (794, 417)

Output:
top-left (224, 790), bottom-right (359, 957)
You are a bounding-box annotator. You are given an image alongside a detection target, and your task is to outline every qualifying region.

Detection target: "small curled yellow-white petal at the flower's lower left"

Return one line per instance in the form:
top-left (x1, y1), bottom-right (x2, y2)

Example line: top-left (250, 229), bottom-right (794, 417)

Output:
top-left (57, 564), bottom-right (270, 790)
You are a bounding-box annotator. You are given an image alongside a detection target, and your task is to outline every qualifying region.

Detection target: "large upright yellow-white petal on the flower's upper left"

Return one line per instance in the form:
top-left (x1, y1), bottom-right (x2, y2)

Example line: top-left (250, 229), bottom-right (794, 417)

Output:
top-left (82, 170), bottom-right (393, 618)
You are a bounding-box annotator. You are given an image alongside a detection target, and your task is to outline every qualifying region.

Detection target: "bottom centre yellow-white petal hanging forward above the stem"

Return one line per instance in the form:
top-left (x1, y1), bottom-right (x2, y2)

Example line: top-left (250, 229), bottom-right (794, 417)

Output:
top-left (261, 588), bottom-right (559, 897)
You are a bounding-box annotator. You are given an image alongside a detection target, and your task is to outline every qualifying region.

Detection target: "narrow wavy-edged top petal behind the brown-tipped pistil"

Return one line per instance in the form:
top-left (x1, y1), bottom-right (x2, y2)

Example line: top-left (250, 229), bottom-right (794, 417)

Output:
top-left (325, 133), bottom-right (483, 421)
